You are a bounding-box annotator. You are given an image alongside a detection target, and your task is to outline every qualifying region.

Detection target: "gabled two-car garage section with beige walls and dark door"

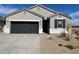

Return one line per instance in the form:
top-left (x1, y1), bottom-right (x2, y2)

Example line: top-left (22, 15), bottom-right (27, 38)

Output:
top-left (4, 10), bottom-right (43, 34)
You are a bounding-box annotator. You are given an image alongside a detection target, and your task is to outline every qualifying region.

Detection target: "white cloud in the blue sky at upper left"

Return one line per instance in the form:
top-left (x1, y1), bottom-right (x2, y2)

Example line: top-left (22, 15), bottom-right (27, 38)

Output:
top-left (0, 5), bottom-right (17, 14)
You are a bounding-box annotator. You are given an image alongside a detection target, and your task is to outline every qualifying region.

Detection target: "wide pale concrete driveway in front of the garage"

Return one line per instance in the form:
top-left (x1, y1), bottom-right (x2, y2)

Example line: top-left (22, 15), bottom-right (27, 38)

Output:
top-left (0, 34), bottom-right (40, 54)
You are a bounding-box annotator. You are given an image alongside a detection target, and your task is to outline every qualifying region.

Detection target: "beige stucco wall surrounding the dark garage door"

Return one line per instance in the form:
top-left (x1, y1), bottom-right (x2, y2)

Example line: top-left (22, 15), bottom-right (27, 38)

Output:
top-left (4, 11), bottom-right (43, 33)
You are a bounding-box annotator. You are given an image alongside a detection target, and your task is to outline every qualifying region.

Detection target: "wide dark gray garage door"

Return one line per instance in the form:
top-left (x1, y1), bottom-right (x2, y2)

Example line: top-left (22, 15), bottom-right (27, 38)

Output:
top-left (11, 21), bottom-right (39, 33)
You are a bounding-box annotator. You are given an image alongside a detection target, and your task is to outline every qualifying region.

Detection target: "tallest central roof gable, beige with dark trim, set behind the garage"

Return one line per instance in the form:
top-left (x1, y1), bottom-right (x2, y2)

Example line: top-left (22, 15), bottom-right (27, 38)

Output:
top-left (28, 5), bottom-right (57, 17)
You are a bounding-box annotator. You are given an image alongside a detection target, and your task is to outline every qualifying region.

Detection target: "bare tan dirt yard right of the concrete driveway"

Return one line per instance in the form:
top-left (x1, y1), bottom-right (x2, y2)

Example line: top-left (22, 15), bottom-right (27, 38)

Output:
top-left (40, 35), bottom-right (79, 54)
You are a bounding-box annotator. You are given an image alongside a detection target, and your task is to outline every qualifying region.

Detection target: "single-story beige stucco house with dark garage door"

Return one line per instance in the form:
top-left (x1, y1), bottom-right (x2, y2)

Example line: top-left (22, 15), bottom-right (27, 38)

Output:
top-left (4, 5), bottom-right (71, 34)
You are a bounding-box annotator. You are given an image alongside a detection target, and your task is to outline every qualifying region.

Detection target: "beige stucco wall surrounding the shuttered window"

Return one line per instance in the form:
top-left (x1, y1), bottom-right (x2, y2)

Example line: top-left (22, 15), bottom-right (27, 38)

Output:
top-left (49, 15), bottom-right (70, 33)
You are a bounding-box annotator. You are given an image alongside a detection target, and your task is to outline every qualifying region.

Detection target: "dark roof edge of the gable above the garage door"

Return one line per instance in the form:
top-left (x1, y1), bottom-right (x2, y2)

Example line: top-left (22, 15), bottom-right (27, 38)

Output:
top-left (4, 8), bottom-right (44, 18)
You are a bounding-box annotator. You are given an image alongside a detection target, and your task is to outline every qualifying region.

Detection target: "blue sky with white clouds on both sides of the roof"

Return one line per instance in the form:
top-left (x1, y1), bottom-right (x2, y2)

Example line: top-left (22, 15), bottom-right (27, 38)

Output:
top-left (0, 4), bottom-right (79, 25)
